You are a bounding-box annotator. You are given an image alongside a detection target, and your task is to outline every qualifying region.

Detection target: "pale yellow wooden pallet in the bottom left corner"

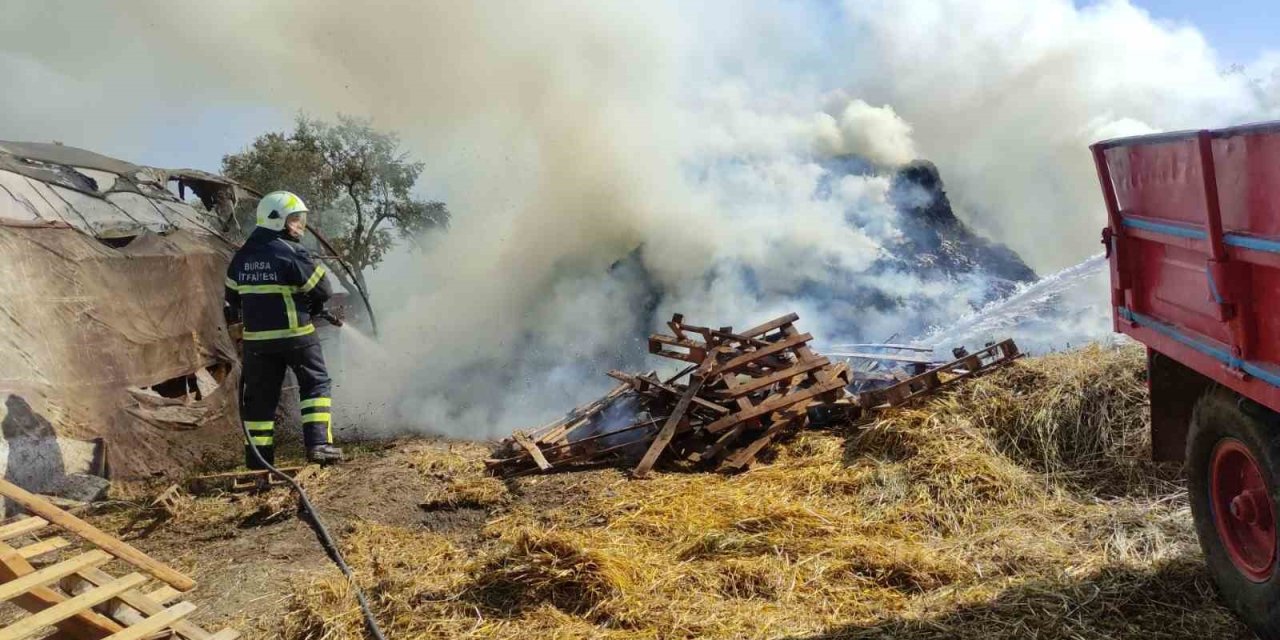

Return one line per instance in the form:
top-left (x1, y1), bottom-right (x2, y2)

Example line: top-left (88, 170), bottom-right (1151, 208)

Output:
top-left (0, 480), bottom-right (239, 640)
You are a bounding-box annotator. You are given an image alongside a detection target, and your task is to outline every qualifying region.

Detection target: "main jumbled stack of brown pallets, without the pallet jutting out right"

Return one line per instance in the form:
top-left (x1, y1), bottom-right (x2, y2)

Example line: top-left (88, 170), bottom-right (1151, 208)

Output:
top-left (488, 314), bottom-right (849, 477)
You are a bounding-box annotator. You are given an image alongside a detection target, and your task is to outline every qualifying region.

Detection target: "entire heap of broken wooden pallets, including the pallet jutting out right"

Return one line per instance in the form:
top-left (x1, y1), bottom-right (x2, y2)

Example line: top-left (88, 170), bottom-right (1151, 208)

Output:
top-left (488, 314), bottom-right (1019, 477)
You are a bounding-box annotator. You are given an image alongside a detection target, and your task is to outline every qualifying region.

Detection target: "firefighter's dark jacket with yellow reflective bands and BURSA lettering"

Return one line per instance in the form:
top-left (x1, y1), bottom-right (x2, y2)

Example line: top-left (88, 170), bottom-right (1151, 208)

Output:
top-left (227, 228), bottom-right (330, 352)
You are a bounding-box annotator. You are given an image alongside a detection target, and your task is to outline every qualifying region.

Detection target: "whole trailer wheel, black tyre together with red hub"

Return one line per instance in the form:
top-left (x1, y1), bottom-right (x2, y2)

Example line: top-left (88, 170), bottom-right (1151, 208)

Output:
top-left (1187, 390), bottom-right (1280, 640)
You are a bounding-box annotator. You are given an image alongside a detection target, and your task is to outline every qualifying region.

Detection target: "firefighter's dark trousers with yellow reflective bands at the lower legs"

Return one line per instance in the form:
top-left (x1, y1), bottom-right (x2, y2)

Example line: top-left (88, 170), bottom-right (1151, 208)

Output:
top-left (241, 343), bottom-right (333, 468)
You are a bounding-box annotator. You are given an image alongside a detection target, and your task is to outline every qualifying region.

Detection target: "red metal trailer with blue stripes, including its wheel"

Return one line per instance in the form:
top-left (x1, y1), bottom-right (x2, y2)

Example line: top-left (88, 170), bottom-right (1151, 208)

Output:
top-left (1092, 123), bottom-right (1280, 637)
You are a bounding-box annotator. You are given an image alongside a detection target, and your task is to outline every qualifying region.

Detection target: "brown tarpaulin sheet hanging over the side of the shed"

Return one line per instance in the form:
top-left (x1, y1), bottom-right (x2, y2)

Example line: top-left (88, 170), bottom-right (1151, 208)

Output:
top-left (0, 225), bottom-right (241, 476)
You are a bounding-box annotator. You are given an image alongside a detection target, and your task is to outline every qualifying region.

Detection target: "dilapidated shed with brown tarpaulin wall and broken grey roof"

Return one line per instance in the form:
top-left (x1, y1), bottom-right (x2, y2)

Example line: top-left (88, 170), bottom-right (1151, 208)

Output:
top-left (0, 142), bottom-right (242, 481)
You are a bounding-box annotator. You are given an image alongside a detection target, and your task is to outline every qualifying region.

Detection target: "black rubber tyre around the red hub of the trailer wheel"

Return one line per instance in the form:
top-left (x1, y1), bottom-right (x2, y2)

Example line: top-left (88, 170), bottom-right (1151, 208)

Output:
top-left (1187, 389), bottom-right (1280, 640)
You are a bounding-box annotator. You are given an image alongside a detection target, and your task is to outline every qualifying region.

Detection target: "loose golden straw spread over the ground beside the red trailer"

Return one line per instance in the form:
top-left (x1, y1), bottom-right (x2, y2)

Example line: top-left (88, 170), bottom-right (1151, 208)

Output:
top-left (282, 348), bottom-right (1245, 640)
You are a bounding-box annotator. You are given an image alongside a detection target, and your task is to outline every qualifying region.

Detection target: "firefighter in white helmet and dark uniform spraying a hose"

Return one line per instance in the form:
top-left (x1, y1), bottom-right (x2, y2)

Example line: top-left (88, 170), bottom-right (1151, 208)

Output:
top-left (227, 191), bottom-right (342, 468)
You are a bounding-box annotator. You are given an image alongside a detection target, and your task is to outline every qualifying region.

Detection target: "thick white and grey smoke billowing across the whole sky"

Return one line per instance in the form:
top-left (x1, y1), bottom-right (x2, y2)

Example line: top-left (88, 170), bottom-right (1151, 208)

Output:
top-left (0, 0), bottom-right (1280, 436)
